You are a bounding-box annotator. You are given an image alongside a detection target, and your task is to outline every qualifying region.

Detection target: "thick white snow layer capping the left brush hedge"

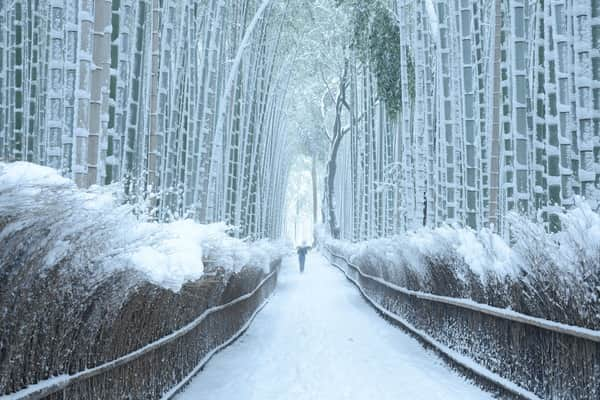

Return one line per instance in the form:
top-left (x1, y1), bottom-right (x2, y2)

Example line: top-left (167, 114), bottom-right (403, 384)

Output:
top-left (0, 162), bottom-right (289, 291)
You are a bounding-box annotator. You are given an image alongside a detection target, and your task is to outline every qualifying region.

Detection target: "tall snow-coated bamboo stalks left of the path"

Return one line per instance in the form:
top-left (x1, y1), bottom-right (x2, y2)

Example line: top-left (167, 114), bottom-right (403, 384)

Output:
top-left (0, 0), bottom-right (288, 237)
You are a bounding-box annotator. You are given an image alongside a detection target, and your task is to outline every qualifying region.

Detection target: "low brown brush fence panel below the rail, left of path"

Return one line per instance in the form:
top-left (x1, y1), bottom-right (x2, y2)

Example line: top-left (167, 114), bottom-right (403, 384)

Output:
top-left (0, 259), bottom-right (281, 400)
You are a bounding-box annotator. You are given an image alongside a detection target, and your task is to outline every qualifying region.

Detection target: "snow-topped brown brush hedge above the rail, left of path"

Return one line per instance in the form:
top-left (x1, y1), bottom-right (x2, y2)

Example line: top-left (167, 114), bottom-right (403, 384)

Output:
top-left (0, 163), bottom-right (289, 394)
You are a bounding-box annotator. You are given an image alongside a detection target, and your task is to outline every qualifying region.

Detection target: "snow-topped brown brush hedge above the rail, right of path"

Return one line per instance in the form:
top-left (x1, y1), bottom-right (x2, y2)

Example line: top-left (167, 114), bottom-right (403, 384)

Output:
top-left (318, 205), bottom-right (600, 329)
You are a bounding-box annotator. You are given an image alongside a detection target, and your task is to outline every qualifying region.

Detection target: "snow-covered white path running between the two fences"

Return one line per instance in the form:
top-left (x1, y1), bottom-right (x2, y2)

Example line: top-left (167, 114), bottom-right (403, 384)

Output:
top-left (177, 253), bottom-right (491, 400)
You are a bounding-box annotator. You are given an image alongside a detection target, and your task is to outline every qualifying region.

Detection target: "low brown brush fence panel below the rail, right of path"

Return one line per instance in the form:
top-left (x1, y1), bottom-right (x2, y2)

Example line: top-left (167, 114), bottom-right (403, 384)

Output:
top-left (326, 247), bottom-right (600, 399)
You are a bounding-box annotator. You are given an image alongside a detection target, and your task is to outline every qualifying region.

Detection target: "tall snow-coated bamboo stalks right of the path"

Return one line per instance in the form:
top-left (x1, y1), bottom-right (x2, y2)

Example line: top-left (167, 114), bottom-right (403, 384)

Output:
top-left (335, 0), bottom-right (600, 240)
